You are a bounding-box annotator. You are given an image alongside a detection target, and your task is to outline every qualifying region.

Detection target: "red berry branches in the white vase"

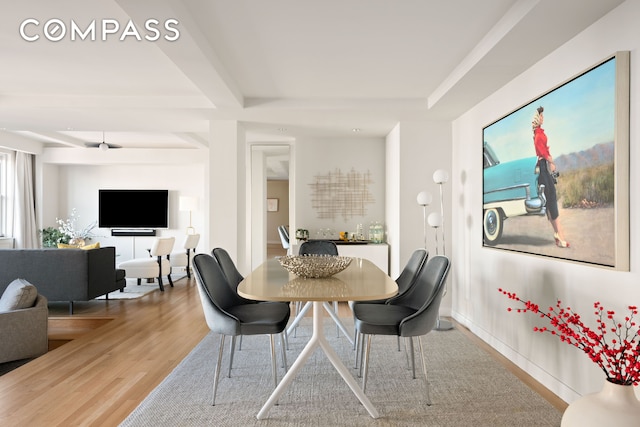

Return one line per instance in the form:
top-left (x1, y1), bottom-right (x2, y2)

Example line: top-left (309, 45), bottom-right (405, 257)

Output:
top-left (498, 289), bottom-right (640, 385)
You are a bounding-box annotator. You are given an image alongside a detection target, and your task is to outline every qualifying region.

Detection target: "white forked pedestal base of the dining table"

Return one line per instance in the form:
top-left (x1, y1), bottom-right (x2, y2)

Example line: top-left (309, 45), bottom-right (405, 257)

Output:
top-left (257, 301), bottom-right (379, 420)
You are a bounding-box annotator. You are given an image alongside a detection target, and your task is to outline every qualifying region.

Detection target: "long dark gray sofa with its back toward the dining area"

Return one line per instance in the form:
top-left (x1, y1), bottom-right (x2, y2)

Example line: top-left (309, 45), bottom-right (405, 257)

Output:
top-left (0, 247), bottom-right (126, 313)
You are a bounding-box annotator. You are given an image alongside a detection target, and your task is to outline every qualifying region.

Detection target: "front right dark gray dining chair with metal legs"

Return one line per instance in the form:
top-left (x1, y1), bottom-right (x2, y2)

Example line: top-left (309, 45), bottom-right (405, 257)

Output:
top-left (354, 255), bottom-right (450, 405)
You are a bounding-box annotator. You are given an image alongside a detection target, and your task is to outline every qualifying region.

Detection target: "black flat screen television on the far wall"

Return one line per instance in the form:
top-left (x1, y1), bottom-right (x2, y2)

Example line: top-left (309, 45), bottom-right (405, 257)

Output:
top-left (98, 190), bottom-right (169, 228)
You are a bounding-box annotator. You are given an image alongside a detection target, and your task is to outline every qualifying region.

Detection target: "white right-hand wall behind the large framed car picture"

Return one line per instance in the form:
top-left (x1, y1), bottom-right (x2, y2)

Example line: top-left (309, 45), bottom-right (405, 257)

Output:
top-left (452, 1), bottom-right (640, 402)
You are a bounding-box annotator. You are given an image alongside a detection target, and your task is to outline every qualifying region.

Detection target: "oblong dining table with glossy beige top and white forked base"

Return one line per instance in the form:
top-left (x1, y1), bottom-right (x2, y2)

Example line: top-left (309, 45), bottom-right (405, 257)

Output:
top-left (238, 258), bottom-right (398, 420)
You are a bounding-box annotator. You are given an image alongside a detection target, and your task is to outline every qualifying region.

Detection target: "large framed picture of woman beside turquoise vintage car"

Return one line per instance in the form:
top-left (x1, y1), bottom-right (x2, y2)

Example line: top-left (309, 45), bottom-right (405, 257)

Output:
top-left (482, 52), bottom-right (629, 271)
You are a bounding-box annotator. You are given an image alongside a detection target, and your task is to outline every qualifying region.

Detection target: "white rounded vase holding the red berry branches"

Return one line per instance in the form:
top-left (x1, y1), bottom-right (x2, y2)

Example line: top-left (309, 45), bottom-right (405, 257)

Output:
top-left (560, 380), bottom-right (640, 427)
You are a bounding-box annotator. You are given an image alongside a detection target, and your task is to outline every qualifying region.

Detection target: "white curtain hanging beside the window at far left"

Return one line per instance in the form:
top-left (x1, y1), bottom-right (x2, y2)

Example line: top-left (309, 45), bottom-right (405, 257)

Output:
top-left (13, 151), bottom-right (40, 249)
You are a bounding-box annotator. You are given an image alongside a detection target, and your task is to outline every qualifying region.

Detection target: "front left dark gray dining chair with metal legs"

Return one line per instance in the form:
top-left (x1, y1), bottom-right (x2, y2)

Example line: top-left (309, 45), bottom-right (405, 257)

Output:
top-left (193, 254), bottom-right (291, 405)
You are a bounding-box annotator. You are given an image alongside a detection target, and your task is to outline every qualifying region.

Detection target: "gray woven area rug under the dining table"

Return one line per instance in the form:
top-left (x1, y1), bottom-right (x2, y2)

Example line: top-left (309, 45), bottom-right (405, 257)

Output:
top-left (121, 319), bottom-right (562, 427)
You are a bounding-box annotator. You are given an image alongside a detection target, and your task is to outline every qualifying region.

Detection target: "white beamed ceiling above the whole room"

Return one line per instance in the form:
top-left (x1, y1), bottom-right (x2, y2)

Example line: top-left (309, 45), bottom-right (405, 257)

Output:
top-left (0, 0), bottom-right (622, 176)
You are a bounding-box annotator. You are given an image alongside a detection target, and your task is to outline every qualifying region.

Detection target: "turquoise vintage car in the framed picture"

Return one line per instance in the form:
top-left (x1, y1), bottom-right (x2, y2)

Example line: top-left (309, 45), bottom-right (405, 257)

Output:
top-left (483, 141), bottom-right (546, 246)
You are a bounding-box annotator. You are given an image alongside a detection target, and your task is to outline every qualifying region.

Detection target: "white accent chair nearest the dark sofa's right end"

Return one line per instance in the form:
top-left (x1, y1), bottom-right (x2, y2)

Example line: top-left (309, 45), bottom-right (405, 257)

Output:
top-left (118, 237), bottom-right (176, 292)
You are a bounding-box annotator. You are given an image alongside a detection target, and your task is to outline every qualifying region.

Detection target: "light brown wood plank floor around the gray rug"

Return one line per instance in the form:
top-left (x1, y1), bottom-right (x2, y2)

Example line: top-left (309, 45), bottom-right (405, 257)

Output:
top-left (0, 260), bottom-right (566, 426)
